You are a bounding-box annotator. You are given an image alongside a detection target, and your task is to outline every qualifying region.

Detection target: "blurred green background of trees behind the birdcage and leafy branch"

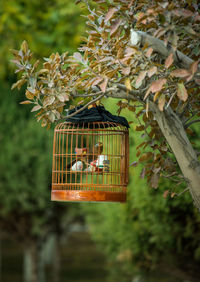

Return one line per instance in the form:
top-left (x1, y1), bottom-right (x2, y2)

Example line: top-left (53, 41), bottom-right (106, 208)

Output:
top-left (0, 0), bottom-right (200, 282)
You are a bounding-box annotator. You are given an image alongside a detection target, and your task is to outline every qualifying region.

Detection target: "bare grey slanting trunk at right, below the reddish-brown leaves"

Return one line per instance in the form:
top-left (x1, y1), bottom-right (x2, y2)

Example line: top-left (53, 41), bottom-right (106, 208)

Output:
top-left (150, 102), bottom-right (200, 210)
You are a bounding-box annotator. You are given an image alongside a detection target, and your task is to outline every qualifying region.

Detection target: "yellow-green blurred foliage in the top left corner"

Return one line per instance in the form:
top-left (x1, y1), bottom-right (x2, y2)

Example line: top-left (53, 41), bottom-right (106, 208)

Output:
top-left (0, 0), bottom-right (85, 80)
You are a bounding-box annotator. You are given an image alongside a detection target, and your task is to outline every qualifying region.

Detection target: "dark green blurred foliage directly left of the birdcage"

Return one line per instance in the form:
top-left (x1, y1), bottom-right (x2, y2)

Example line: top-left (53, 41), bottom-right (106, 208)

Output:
top-left (0, 83), bottom-right (52, 240)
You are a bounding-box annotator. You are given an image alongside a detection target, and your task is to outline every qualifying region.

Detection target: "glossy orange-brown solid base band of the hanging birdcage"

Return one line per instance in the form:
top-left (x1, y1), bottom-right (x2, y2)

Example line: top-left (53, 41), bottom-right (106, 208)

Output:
top-left (51, 190), bottom-right (126, 203)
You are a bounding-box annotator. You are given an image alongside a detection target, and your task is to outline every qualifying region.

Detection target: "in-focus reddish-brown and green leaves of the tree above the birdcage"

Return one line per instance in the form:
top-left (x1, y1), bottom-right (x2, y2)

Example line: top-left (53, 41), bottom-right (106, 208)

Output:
top-left (13, 0), bottom-right (200, 195)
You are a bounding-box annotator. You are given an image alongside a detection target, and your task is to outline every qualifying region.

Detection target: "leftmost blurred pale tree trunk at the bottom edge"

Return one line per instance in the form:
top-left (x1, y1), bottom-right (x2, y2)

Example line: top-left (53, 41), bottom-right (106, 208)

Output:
top-left (24, 242), bottom-right (38, 282)
